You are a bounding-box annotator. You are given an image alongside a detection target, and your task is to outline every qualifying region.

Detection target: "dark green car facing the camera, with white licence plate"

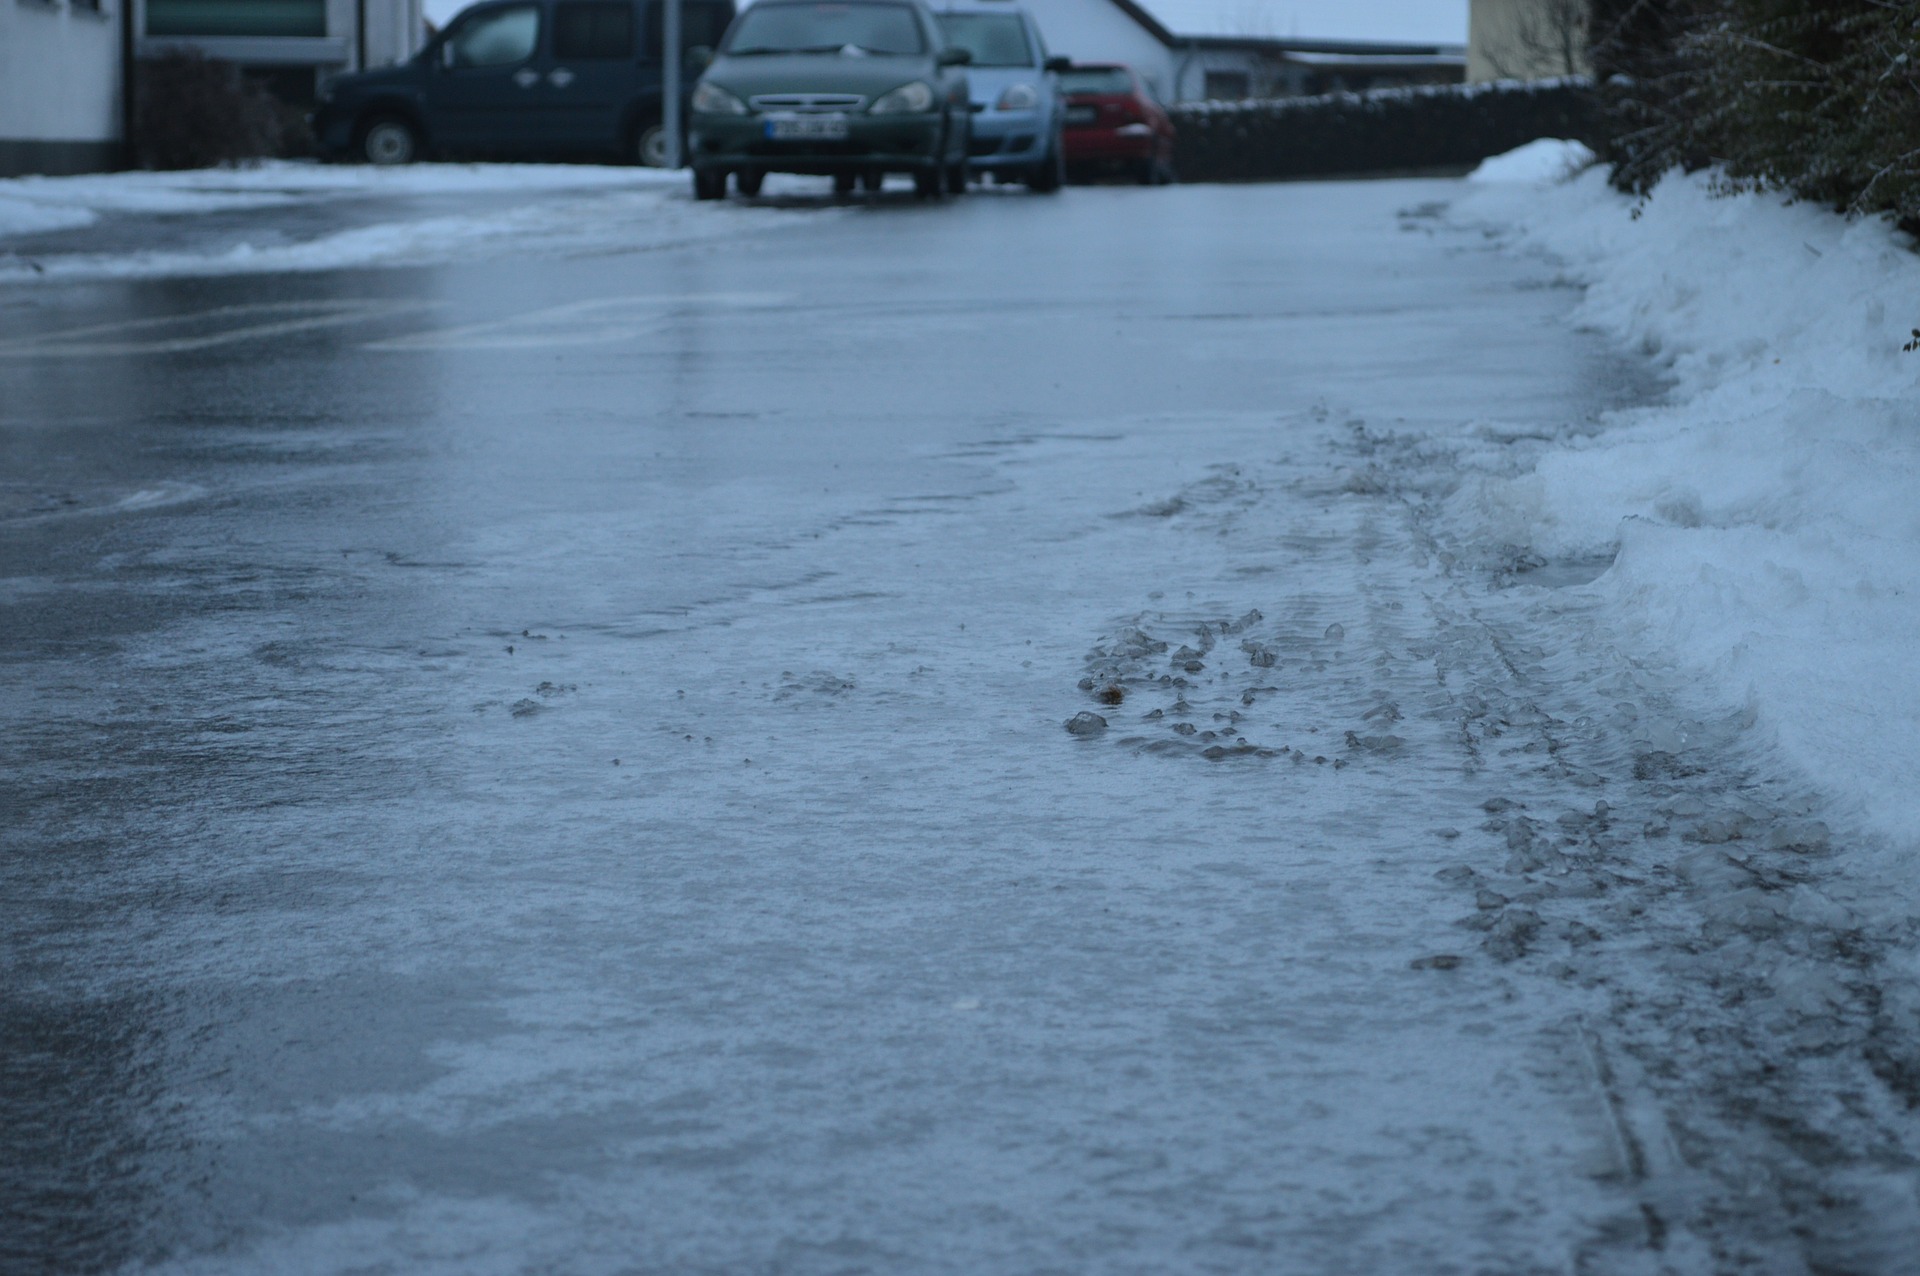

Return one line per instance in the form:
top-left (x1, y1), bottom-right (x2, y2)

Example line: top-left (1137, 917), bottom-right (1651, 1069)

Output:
top-left (687, 0), bottom-right (973, 200)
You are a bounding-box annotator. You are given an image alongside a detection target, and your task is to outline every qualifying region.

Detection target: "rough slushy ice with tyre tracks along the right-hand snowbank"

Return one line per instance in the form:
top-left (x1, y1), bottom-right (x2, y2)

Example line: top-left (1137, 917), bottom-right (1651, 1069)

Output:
top-left (1079, 412), bottom-right (1920, 1274)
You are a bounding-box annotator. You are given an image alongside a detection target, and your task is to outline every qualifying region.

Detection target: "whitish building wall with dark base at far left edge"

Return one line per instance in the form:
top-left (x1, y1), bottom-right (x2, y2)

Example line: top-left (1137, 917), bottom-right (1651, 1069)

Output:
top-left (0, 0), bottom-right (131, 175)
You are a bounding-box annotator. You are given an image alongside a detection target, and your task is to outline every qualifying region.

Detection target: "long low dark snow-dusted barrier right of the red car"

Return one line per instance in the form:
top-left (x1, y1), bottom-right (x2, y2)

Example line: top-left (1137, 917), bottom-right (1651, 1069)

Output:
top-left (1171, 79), bottom-right (1603, 182)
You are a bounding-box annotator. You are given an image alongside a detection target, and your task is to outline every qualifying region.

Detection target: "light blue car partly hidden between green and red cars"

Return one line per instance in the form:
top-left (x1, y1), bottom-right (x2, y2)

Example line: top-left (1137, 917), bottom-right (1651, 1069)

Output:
top-left (939, 0), bottom-right (1071, 192)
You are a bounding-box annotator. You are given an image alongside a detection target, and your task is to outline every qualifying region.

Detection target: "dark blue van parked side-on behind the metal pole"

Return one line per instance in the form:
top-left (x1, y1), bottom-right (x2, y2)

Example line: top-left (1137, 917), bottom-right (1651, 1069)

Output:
top-left (313, 0), bottom-right (733, 165)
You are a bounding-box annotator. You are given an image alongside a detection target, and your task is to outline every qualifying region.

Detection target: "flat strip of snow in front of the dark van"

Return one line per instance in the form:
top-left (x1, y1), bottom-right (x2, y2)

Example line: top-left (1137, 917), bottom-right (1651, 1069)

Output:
top-left (0, 161), bottom-right (817, 282)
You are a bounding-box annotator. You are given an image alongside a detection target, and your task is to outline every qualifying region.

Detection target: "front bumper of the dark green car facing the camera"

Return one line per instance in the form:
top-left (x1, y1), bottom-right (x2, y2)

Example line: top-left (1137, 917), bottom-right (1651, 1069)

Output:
top-left (687, 111), bottom-right (947, 175)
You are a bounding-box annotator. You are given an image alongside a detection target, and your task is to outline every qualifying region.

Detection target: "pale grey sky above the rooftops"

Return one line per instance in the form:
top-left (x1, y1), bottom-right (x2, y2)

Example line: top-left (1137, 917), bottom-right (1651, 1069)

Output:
top-left (426, 0), bottom-right (1467, 44)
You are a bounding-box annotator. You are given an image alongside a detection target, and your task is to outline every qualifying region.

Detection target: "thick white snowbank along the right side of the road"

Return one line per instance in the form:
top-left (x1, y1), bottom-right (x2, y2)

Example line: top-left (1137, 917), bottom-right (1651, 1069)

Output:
top-left (1452, 159), bottom-right (1920, 848)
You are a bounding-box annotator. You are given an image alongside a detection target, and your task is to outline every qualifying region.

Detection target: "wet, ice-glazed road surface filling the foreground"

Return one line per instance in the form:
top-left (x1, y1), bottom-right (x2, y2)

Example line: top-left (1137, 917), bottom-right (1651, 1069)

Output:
top-left (0, 182), bottom-right (1920, 1276)
